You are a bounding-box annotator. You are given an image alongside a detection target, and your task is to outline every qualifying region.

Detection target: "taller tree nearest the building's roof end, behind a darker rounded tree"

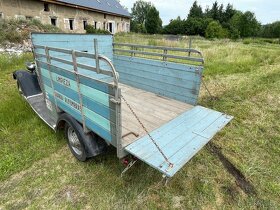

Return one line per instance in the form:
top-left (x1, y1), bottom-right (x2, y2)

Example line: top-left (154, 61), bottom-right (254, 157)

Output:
top-left (131, 0), bottom-right (152, 24)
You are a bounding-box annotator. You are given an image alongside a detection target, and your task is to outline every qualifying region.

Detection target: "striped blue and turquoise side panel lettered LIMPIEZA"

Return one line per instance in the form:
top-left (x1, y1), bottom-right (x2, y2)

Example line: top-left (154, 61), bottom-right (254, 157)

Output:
top-left (38, 62), bottom-right (116, 145)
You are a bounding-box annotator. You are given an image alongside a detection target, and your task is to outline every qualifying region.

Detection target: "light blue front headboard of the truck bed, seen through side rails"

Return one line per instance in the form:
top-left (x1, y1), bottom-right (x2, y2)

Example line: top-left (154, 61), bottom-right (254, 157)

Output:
top-left (32, 33), bottom-right (113, 80)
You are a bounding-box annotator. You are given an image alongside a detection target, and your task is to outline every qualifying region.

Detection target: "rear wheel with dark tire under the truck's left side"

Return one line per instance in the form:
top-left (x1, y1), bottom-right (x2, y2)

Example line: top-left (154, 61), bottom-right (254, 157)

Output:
top-left (65, 123), bottom-right (87, 162)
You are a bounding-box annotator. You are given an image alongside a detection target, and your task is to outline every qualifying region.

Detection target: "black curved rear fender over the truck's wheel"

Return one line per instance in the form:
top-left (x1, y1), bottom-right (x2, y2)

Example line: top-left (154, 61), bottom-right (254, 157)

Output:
top-left (56, 113), bottom-right (107, 158)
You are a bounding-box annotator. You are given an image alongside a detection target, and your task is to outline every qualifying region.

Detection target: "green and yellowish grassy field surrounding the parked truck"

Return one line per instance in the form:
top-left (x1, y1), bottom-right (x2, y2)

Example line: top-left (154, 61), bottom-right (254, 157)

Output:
top-left (0, 35), bottom-right (280, 209)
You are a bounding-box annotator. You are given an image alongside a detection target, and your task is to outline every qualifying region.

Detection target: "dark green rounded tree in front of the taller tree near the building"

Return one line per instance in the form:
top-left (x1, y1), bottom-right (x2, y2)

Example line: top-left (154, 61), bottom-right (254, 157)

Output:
top-left (145, 6), bottom-right (162, 34)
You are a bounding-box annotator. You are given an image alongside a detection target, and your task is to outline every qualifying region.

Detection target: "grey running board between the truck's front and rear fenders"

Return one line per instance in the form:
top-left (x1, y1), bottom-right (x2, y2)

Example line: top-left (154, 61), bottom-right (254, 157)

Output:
top-left (25, 93), bottom-right (56, 130)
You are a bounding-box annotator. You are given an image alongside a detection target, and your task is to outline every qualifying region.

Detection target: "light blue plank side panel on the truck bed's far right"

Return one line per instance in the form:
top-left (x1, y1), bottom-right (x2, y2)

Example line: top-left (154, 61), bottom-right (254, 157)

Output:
top-left (114, 55), bottom-right (203, 105)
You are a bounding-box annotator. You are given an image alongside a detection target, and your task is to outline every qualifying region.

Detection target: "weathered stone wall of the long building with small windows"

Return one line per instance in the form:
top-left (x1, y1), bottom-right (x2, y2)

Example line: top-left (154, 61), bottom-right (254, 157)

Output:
top-left (0, 0), bottom-right (130, 33)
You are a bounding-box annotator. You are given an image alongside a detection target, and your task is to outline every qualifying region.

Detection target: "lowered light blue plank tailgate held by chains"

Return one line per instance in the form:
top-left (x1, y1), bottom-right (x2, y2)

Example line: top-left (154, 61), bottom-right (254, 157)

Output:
top-left (125, 106), bottom-right (233, 177)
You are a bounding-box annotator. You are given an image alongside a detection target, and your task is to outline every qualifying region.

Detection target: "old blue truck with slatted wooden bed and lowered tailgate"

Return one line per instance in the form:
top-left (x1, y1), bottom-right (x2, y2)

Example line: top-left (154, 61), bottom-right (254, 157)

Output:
top-left (13, 33), bottom-right (233, 177)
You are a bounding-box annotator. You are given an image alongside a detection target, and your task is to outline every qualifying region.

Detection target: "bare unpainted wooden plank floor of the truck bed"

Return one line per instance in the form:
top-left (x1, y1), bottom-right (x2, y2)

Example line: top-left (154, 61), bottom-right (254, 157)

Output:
top-left (119, 84), bottom-right (193, 146)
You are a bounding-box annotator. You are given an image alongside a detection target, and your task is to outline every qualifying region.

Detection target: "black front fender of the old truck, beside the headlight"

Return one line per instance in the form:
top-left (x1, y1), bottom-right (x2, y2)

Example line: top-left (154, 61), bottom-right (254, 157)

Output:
top-left (13, 70), bottom-right (42, 97)
